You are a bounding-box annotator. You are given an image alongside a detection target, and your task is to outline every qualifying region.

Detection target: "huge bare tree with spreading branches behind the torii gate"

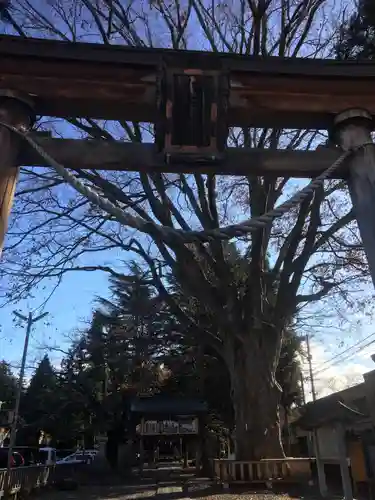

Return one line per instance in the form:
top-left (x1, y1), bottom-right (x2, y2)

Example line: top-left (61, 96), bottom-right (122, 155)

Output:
top-left (0, 0), bottom-right (367, 459)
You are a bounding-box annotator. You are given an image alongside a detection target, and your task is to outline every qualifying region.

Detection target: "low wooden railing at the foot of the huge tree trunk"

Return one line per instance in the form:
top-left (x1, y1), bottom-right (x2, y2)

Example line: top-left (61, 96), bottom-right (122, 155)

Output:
top-left (214, 458), bottom-right (315, 483)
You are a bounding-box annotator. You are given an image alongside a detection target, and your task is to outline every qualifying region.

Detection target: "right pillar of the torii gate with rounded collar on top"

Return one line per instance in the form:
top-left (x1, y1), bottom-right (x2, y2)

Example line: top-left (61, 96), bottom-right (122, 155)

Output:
top-left (333, 109), bottom-right (375, 286)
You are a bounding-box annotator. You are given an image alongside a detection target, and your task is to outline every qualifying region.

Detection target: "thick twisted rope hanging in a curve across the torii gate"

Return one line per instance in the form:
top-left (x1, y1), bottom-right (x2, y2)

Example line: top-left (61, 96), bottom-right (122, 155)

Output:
top-left (0, 122), bottom-right (364, 242)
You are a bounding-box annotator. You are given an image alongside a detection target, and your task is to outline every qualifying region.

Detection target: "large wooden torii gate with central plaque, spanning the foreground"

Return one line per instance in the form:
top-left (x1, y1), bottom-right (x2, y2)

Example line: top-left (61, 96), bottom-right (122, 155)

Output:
top-left (0, 35), bottom-right (375, 282)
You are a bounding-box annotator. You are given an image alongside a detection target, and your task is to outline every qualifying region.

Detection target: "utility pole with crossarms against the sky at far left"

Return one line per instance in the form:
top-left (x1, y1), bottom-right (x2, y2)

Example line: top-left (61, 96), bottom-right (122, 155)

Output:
top-left (4, 311), bottom-right (48, 498)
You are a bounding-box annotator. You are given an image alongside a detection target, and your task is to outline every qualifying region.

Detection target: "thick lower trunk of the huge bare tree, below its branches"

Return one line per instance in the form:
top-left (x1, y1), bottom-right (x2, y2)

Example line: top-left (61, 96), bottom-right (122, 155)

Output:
top-left (229, 336), bottom-right (285, 460)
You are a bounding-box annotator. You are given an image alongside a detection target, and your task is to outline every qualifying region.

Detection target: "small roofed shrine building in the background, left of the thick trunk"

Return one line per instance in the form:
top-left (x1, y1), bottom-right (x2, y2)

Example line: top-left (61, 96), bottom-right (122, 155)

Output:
top-left (130, 396), bottom-right (207, 468)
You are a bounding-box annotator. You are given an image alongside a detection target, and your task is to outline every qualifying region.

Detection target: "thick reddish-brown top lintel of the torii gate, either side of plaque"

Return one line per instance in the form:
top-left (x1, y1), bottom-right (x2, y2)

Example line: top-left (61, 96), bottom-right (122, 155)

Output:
top-left (0, 35), bottom-right (375, 129)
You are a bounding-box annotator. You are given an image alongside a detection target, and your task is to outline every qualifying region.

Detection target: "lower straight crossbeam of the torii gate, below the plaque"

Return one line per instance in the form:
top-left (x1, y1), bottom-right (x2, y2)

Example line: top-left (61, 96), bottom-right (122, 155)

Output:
top-left (17, 136), bottom-right (345, 178)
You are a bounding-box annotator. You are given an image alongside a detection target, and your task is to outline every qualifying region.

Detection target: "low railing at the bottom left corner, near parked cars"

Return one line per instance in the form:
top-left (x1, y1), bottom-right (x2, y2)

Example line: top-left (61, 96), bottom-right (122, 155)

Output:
top-left (0, 464), bottom-right (77, 498)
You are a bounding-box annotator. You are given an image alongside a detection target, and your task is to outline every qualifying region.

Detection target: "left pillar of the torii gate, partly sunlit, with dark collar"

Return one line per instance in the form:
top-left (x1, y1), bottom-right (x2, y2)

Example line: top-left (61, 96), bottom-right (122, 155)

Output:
top-left (0, 90), bottom-right (35, 257)
